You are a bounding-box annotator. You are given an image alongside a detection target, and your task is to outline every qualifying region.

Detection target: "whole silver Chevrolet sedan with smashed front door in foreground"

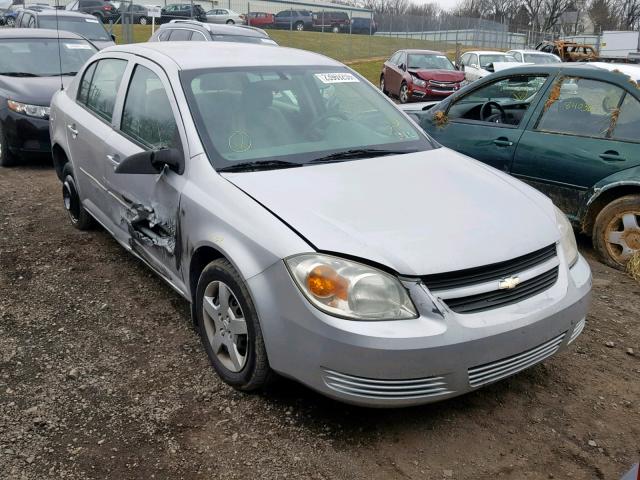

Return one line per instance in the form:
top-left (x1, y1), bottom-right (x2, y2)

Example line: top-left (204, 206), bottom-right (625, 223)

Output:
top-left (51, 42), bottom-right (591, 407)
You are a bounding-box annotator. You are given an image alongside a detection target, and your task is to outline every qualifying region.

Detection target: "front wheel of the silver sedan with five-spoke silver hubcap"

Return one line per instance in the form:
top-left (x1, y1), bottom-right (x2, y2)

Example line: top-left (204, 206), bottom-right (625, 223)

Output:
top-left (195, 259), bottom-right (273, 392)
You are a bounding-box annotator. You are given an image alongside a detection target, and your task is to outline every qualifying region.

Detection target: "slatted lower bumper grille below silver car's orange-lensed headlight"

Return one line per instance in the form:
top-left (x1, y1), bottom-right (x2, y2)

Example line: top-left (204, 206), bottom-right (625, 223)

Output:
top-left (324, 369), bottom-right (453, 400)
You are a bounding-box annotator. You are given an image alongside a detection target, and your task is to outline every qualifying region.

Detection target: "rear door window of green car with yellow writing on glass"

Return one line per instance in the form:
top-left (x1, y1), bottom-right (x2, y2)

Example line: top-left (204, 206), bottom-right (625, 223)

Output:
top-left (536, 77), bottom-right (624, 138)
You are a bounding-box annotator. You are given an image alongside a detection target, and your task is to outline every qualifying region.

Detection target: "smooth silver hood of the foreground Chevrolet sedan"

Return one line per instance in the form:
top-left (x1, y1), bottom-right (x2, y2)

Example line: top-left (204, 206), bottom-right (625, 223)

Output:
top-left (223, 152), bottom-right (560, 276)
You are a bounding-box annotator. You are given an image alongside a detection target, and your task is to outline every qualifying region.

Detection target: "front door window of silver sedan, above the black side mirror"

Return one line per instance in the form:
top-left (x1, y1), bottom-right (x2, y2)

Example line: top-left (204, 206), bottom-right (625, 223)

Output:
top-left (120, 65), bottom-right (180, 150)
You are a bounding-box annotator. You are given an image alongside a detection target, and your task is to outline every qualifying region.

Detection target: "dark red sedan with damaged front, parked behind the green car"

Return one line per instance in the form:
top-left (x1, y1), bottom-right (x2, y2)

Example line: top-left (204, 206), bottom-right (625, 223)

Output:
top-left (380, 50), bottom-right (464, 103)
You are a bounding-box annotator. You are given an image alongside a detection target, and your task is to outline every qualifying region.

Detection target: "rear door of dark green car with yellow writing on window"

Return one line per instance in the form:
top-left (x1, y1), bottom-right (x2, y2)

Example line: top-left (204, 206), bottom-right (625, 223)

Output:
top-left (511, 73), bottom-right (640, 224)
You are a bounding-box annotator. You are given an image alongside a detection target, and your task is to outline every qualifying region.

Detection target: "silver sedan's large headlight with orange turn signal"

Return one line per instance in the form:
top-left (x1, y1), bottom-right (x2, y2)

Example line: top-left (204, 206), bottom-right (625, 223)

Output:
top-left (285, 253), bottom-right (418, 320)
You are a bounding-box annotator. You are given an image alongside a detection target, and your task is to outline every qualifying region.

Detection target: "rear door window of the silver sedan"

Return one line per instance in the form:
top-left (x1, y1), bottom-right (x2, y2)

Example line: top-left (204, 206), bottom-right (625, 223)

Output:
top-left (85, 58), bottom-right (127, 122)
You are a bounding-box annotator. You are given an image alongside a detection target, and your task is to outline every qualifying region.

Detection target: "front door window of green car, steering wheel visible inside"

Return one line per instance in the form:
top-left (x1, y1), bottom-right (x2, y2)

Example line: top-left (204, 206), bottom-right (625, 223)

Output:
top-left (447, 75), bottom-right (547, 126)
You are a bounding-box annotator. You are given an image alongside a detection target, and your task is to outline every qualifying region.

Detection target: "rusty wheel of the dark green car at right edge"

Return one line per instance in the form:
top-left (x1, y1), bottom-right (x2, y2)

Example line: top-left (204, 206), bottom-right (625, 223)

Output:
top-left (592, 195), bottom-right (640, 270)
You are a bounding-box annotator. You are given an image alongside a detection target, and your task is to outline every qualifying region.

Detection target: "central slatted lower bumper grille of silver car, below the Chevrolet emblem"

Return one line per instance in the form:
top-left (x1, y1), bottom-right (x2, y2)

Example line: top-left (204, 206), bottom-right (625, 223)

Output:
top-left (468, 332), bottom-right (566, 387)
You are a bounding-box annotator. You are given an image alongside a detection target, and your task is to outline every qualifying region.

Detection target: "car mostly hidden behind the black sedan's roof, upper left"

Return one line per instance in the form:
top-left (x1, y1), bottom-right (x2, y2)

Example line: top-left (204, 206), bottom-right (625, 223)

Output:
top-left (16, 8), bottom-right (115, 50)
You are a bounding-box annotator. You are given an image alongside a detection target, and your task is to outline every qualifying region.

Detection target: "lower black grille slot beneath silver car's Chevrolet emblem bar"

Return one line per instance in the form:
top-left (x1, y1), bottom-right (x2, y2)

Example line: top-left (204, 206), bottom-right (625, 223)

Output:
top-left (445, 267), bottom-right (558, 313)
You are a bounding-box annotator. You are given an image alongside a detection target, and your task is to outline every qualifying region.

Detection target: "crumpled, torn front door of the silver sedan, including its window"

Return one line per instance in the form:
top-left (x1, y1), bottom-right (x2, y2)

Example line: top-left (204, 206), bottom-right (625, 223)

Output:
top-left (105, 60), bottom-right (185, 288)
